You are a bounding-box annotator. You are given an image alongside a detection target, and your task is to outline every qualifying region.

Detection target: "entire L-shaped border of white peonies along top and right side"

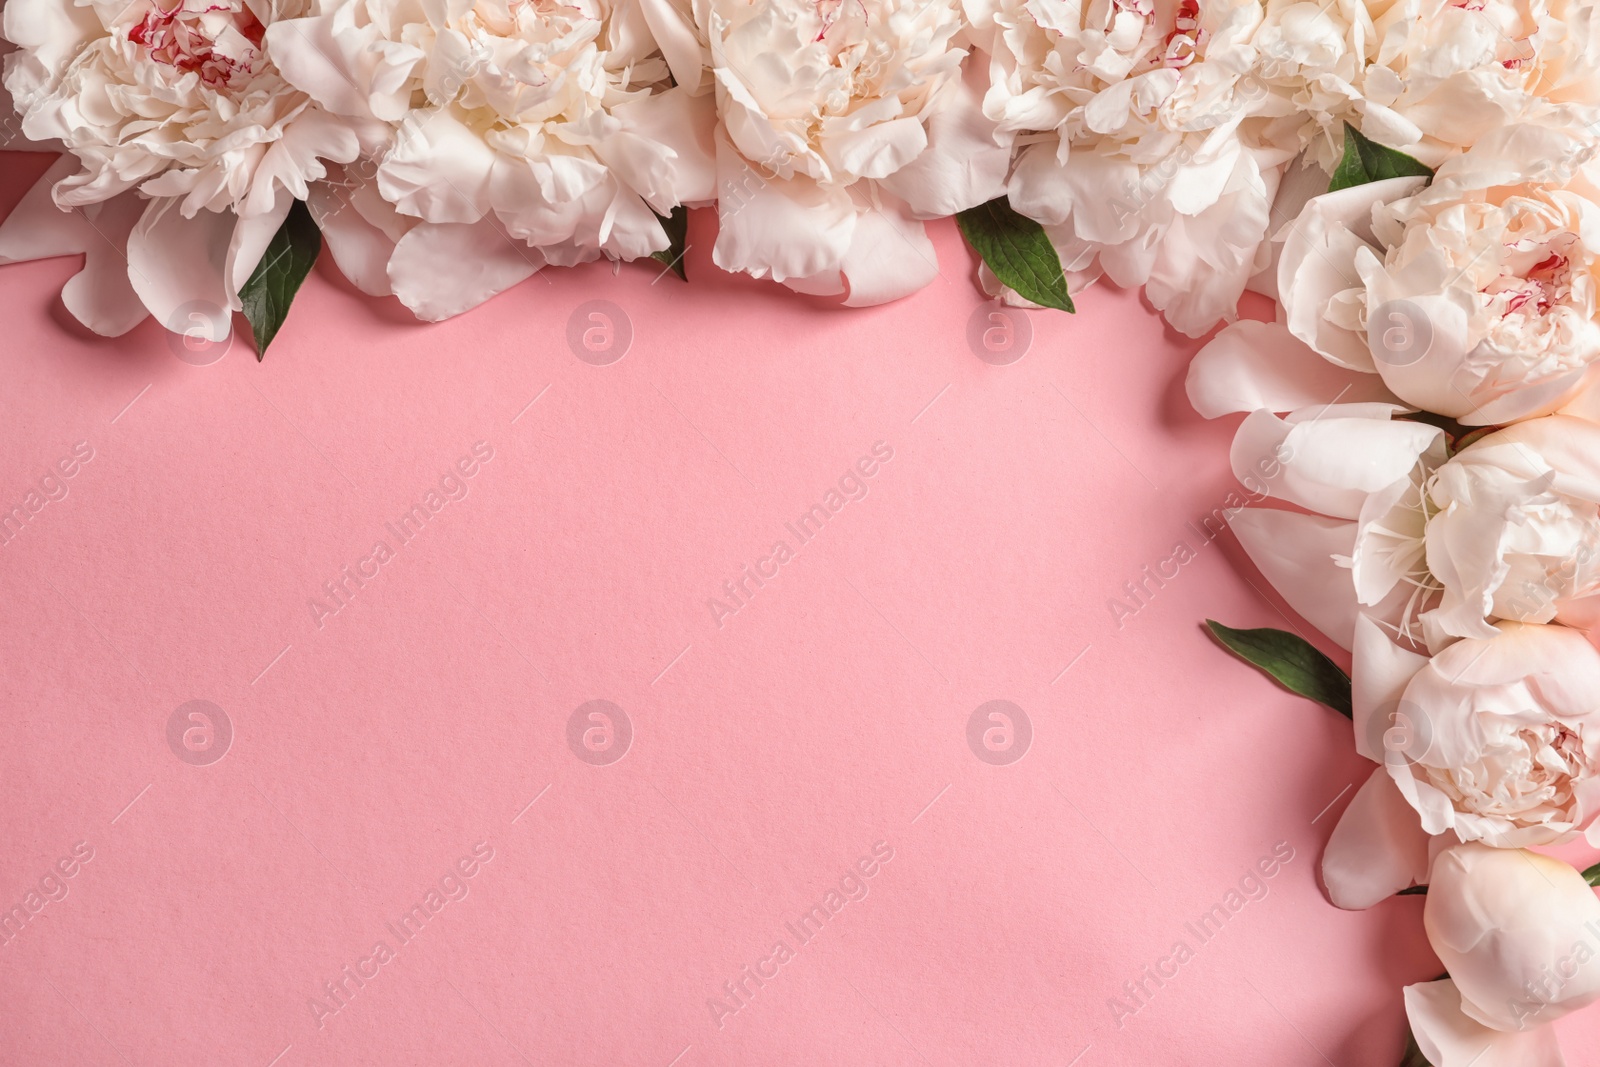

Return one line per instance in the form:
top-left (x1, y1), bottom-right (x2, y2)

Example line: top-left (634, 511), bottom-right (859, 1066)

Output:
top-left (9, 0), bottom-right (1600, 1067)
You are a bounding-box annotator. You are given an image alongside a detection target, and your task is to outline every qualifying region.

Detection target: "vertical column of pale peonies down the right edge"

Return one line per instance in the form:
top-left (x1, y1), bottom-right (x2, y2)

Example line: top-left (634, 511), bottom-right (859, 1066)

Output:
top-left (1187, 97), bottom-right (1600, 1067)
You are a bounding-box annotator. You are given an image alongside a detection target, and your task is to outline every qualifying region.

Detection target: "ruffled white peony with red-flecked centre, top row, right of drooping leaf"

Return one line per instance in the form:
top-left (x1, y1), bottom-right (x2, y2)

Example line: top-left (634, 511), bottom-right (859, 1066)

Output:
top-left (974, 0), bottom-right (1298, 336)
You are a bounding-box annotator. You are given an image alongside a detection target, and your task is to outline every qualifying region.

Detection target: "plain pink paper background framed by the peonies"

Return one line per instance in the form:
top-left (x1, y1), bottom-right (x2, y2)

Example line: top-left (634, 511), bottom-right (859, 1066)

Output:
top-left (0, 157), bottom-right (1600, 1067)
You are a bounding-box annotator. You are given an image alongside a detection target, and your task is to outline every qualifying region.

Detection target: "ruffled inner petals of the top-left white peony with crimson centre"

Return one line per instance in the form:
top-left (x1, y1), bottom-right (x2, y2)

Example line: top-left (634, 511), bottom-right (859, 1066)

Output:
top-left (5, 0), bottom-right (357, 216)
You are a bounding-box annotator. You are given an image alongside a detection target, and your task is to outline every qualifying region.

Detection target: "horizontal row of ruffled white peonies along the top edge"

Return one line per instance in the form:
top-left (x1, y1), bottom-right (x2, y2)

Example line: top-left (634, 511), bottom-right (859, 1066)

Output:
top-left (9, 0), bottom-right (1600, 340)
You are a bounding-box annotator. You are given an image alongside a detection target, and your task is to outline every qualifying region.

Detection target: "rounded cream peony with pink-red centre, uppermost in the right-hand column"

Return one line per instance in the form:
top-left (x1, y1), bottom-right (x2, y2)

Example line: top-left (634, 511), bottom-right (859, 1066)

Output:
top-left (1190, 126), bottom-right (1600, 426)
